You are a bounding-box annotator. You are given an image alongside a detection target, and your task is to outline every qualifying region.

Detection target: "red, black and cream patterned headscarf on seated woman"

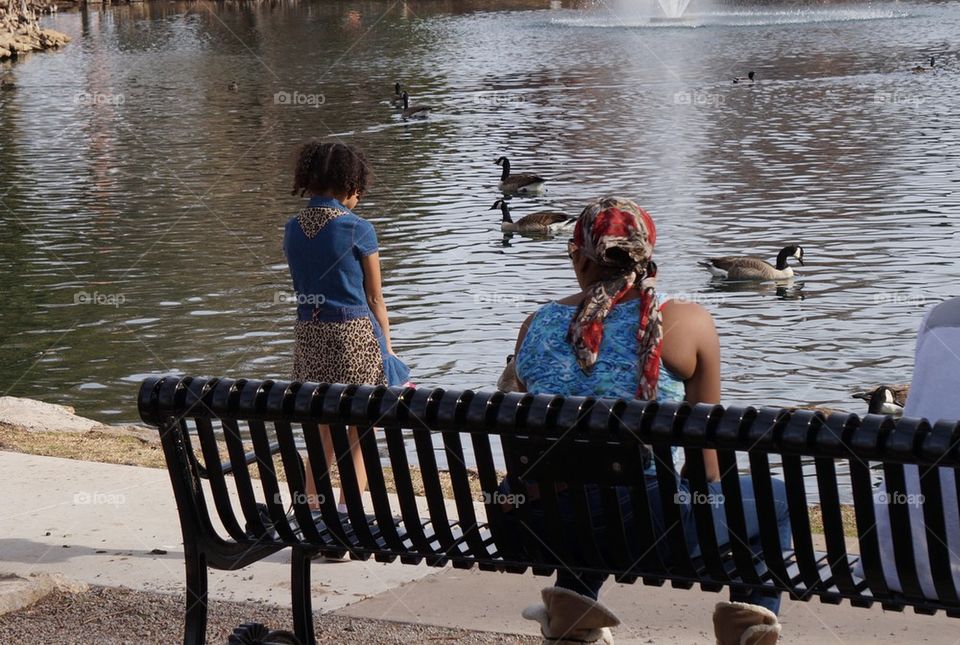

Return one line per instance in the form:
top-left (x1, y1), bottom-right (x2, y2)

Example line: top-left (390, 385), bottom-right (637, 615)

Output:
top-left (567, 197), bottom-right (663, 401)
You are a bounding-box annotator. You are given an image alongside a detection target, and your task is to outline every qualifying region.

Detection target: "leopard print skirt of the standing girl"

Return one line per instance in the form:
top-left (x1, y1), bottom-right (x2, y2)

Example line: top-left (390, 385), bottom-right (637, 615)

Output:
top-left (293, 318), bottom-right (387, 385)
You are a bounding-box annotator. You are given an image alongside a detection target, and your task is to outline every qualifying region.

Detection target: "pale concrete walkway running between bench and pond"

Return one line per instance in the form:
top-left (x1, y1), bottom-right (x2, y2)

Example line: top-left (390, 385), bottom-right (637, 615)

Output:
top-left (0, 452), bottom-right (960, 645)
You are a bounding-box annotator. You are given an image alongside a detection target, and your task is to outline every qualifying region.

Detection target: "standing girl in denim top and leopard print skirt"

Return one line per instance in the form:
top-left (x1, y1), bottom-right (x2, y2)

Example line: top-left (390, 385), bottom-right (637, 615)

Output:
top-left (283, 141), bottom-right (410, 508)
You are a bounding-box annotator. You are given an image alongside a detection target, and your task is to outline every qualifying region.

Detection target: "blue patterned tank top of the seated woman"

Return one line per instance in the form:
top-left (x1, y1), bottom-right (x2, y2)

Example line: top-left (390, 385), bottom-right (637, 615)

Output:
top-left (516, 299), bottom-right (686, 474)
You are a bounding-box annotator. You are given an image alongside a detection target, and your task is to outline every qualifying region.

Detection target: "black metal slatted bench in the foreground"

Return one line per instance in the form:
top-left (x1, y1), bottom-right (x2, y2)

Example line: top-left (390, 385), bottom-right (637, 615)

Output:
top-left (139, 377), bottom-right (960, 643)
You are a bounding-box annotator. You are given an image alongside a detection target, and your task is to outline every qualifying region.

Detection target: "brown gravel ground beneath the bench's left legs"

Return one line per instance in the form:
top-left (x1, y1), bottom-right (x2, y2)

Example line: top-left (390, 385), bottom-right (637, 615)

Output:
top-left (0, 587), bottom-right (540, 645)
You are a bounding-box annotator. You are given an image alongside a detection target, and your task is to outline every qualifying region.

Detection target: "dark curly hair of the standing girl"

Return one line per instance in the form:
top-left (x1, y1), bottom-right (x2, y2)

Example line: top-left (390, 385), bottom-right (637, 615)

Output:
top-left (291, 140), bottom-right (370, 197)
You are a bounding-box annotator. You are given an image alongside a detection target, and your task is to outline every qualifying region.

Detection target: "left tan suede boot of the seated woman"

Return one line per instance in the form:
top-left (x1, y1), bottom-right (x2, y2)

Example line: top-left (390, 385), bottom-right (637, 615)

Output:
top-left (522, 587), bottom-right (620, 645)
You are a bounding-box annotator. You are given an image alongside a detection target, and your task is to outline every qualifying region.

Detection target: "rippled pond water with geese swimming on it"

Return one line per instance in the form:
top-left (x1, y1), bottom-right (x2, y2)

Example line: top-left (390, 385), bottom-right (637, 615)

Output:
top-left (0, 0), bottom-right (960, 422)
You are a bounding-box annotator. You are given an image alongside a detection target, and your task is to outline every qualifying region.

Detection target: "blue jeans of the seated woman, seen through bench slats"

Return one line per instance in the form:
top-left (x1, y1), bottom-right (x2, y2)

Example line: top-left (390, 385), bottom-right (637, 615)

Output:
top-left (501, 476), bottom-right (792, 613)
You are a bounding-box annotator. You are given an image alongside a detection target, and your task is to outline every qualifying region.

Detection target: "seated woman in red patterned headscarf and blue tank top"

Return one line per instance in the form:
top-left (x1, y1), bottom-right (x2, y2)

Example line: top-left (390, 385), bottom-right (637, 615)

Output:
top-left (506, 197), bottom-right (791, 645)
